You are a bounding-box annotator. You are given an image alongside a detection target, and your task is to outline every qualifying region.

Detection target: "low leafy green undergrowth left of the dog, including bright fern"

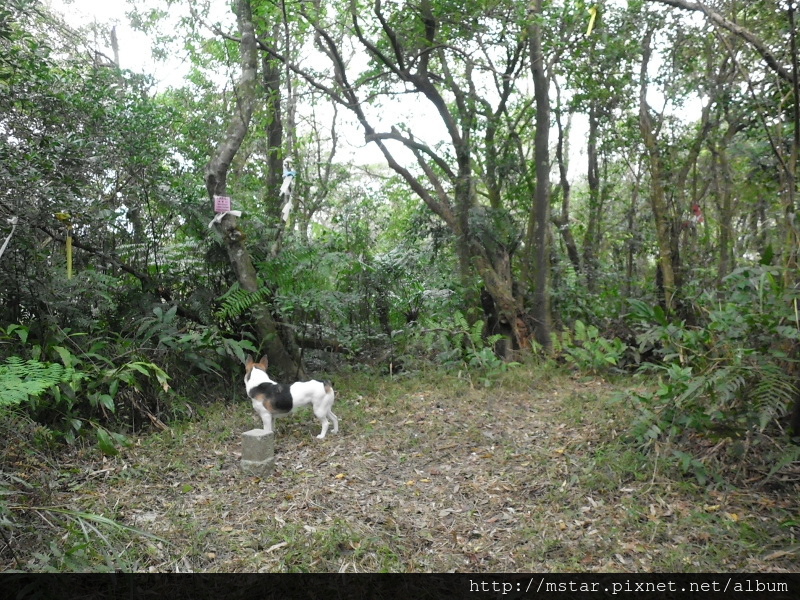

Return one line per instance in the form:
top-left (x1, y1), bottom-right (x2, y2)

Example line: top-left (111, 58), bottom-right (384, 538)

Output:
top-left (0, 314), bottom-right (255, 455)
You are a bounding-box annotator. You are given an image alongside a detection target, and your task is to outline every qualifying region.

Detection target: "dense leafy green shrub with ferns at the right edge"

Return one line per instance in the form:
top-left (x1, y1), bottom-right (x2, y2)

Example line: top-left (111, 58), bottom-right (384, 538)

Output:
top-left (628, 265), bottom-right (800, 482)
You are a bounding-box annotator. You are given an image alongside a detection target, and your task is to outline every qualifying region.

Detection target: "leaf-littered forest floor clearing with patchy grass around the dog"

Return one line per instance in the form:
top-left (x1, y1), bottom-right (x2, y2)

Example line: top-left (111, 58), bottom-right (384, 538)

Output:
top-left (0, 367), bottom-right (800, 572)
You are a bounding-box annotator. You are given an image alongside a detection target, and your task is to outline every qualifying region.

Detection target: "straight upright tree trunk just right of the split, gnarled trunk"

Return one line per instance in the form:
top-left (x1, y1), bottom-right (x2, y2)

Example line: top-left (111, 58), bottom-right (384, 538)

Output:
top-left (528, 0), bottom-right (553, 352)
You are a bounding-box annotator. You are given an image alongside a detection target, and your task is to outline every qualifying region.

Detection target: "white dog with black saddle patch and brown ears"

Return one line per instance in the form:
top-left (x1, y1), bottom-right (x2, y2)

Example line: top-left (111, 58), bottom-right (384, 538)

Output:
top-left (244, 355), bottom-right (339, 440)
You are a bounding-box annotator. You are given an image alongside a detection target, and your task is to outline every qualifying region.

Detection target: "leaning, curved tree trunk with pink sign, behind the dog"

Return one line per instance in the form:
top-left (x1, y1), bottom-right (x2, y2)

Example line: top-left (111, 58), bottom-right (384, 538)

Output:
top-left (206, 0), bottom-right (305, 378)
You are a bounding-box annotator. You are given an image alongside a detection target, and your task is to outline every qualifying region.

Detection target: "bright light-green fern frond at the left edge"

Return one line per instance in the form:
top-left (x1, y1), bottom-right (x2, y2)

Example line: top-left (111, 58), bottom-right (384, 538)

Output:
top-left (0, 356), bottom-right (75, 407)
